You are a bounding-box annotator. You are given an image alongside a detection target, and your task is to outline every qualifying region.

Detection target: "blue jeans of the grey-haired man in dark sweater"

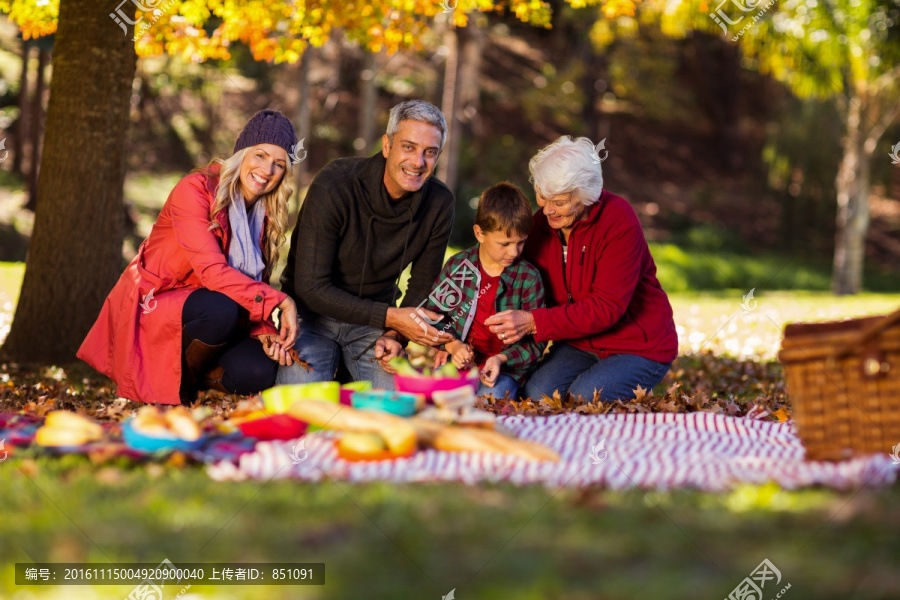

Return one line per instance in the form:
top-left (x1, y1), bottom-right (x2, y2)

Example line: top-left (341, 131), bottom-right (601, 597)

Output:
top-left (275, 314), bottom-right (394, 390)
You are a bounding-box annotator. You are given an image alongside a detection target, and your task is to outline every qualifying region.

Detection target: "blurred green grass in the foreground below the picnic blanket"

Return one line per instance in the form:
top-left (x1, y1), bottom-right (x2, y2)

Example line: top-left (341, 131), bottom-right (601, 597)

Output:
top-left (0, 457), bottom-right (900, 600)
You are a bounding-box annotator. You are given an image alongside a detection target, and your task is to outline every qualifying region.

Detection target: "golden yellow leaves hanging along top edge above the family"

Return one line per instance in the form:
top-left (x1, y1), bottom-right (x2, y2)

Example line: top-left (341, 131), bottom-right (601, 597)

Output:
top-left (0, 0), bottom-right (635, 63)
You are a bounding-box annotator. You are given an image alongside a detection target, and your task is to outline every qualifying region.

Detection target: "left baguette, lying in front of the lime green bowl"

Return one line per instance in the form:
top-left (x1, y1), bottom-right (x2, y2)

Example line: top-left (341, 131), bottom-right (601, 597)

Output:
top-left (288, 400), bottom-right (416, 455)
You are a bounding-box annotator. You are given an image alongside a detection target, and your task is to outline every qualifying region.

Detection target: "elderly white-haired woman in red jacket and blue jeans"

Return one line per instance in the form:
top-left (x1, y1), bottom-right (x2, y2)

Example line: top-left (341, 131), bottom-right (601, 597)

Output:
top-left (485, 136), bottom-right (678, 401)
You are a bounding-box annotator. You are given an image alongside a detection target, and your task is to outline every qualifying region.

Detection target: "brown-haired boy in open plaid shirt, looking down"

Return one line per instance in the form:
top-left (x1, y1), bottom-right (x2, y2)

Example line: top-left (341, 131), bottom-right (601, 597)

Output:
top-left (426, 182), bottom-right (544, 398)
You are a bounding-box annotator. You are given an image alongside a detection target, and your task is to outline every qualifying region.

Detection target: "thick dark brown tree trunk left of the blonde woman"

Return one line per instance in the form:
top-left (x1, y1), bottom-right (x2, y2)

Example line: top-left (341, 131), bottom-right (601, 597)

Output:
top-left (2, 0), bottom-right (136, 362)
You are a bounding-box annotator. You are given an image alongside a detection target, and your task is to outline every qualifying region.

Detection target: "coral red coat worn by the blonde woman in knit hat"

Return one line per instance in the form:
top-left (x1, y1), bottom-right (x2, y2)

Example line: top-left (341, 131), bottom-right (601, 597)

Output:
top-left (78, 165), bottom-right (286, 404)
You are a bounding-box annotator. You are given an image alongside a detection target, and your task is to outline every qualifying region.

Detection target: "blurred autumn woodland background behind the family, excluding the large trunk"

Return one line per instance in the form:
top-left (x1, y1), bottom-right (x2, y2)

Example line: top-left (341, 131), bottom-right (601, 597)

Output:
top-left (0, 0), bottom-right (900, 364)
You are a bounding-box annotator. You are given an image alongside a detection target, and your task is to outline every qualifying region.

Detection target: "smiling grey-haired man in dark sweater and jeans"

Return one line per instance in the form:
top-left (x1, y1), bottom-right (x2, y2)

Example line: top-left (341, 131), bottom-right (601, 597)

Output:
top-left (277, 100), bottom-right (453, 389)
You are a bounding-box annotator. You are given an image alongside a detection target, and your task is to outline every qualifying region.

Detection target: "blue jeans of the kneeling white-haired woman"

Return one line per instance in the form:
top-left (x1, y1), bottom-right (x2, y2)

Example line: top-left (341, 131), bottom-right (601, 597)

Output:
top-left (525, 342), bottom-right (672, 402)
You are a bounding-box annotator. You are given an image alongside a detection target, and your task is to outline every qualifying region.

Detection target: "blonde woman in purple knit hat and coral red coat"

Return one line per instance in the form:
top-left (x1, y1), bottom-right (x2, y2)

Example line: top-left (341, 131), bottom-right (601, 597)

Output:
top-left (78, 110), bottom-right (298, 404)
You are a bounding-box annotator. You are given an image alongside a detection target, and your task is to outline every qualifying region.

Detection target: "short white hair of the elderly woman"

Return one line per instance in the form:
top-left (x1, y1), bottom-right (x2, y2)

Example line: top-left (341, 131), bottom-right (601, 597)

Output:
top-left (528, 135), bottom-right (603, 206)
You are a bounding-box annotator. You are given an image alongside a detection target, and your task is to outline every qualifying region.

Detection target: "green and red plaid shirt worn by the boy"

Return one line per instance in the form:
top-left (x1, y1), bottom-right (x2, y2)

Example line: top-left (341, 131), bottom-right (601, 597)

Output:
top-left (422, 244), bottom-right (545, 385)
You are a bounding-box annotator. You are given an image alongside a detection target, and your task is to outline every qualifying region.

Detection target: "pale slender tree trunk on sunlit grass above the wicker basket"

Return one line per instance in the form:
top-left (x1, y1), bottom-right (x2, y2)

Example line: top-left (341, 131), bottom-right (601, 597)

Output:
top-left (831, 96), bottom-right (870, 295)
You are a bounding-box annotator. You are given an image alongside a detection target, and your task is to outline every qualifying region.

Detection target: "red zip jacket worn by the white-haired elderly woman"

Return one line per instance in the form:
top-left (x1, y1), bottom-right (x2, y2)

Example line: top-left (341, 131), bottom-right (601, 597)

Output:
top-left (525, 191), bottom-right (678, 362)
